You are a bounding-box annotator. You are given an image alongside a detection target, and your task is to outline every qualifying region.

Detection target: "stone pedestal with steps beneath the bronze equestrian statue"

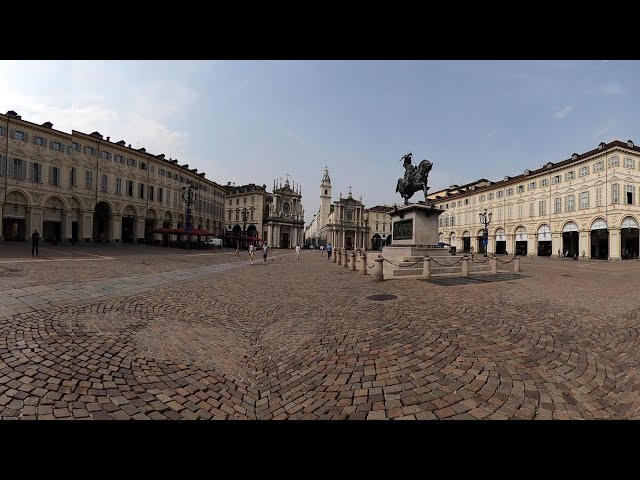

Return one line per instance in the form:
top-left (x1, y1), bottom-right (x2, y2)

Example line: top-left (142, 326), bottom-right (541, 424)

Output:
top-left (382, 203), bottom-right (449, 279)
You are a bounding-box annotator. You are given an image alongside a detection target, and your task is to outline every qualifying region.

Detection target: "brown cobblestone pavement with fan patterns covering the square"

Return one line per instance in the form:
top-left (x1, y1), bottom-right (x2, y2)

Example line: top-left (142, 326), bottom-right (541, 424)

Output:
top-left (0, 247), bottom-right (640, 419)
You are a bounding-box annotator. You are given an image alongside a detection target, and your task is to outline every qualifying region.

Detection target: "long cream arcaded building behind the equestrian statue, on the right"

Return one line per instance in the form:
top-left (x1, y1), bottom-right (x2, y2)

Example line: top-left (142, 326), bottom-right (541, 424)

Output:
top-left (428, 140), bottom-right (640, 260)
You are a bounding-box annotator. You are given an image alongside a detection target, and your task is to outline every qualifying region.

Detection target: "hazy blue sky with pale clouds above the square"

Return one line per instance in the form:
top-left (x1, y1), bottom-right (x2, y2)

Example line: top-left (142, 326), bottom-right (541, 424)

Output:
top-left (0, 60), bottom-right (640, 223)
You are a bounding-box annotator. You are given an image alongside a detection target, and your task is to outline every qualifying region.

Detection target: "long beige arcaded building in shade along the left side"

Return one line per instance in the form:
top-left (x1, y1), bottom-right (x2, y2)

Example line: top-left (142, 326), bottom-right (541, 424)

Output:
top-left (0, 111), bottom-right (224, 242)
